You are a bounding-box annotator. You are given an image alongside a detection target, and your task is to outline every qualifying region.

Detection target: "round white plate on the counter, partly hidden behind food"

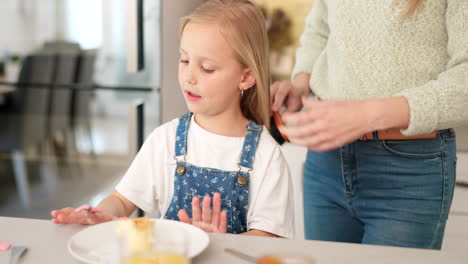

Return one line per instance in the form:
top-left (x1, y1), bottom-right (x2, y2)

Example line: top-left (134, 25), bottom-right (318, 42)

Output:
top-left (68, 219), bottom-right (210, 264)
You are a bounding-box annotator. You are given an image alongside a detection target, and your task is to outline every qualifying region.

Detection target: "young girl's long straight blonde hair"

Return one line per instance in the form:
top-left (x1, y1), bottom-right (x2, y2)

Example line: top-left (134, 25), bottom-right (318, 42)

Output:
top-left (180, 0), bottom-right (270, 128)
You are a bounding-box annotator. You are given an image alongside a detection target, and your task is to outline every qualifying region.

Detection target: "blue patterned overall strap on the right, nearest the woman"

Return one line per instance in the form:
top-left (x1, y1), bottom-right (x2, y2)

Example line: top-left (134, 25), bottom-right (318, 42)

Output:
top-left (239, 120), bottom-right (263, 169)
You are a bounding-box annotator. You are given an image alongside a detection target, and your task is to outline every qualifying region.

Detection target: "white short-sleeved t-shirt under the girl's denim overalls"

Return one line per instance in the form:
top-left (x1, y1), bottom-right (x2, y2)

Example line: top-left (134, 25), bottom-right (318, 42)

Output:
top-left (116, 118), bottom-right (294, 238)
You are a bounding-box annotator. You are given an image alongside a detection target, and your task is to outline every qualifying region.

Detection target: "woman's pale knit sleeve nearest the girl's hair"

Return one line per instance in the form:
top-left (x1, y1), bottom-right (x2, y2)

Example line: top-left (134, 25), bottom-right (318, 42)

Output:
top-left (291, 0), bottom-right (330, 79)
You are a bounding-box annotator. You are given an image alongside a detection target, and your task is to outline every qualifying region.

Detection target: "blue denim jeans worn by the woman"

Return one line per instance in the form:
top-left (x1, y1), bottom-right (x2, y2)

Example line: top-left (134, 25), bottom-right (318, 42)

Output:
top-left (304, 129), bottom-right (456, 249)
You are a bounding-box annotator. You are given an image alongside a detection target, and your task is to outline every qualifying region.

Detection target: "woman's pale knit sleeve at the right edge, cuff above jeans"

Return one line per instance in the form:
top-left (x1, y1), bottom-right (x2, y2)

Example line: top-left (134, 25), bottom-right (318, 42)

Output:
top-left (397, 0), bottom-right (468, 135)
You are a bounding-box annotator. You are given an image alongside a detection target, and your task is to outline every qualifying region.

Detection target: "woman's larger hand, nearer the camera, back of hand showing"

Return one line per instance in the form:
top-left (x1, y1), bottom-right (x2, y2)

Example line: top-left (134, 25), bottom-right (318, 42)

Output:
top-left (280, 98), bottom-right (374, 151)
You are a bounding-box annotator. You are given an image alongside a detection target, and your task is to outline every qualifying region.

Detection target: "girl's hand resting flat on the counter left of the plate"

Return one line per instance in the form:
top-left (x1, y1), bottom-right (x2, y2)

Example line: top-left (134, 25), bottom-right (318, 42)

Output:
top-left (50, 207), bottom-right (127, 225)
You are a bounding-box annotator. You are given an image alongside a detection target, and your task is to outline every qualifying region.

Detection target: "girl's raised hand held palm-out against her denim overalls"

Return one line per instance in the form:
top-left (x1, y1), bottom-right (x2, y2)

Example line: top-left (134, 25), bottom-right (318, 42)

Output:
top-left (177, 193), bottom-right (227, 233)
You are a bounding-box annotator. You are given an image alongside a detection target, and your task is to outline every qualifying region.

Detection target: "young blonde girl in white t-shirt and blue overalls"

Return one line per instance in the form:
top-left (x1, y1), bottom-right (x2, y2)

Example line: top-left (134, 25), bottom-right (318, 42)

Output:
top-left (51, 0), bottom-right (294, 237)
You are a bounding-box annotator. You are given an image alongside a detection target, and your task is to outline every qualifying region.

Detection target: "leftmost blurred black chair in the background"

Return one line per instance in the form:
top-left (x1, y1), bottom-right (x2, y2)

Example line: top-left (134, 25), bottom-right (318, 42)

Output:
top-left (0, 54), bottom-right (55, 208)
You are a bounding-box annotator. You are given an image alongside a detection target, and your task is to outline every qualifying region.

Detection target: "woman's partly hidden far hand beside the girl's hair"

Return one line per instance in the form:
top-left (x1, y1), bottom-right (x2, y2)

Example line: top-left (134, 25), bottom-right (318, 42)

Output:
top-left (270, 73), bottom-right (310, 112)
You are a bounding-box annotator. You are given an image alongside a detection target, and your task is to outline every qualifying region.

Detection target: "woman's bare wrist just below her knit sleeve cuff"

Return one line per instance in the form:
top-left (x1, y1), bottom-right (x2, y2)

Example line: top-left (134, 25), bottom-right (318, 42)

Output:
top-left (365, 96), bottom-right (410, 131)
